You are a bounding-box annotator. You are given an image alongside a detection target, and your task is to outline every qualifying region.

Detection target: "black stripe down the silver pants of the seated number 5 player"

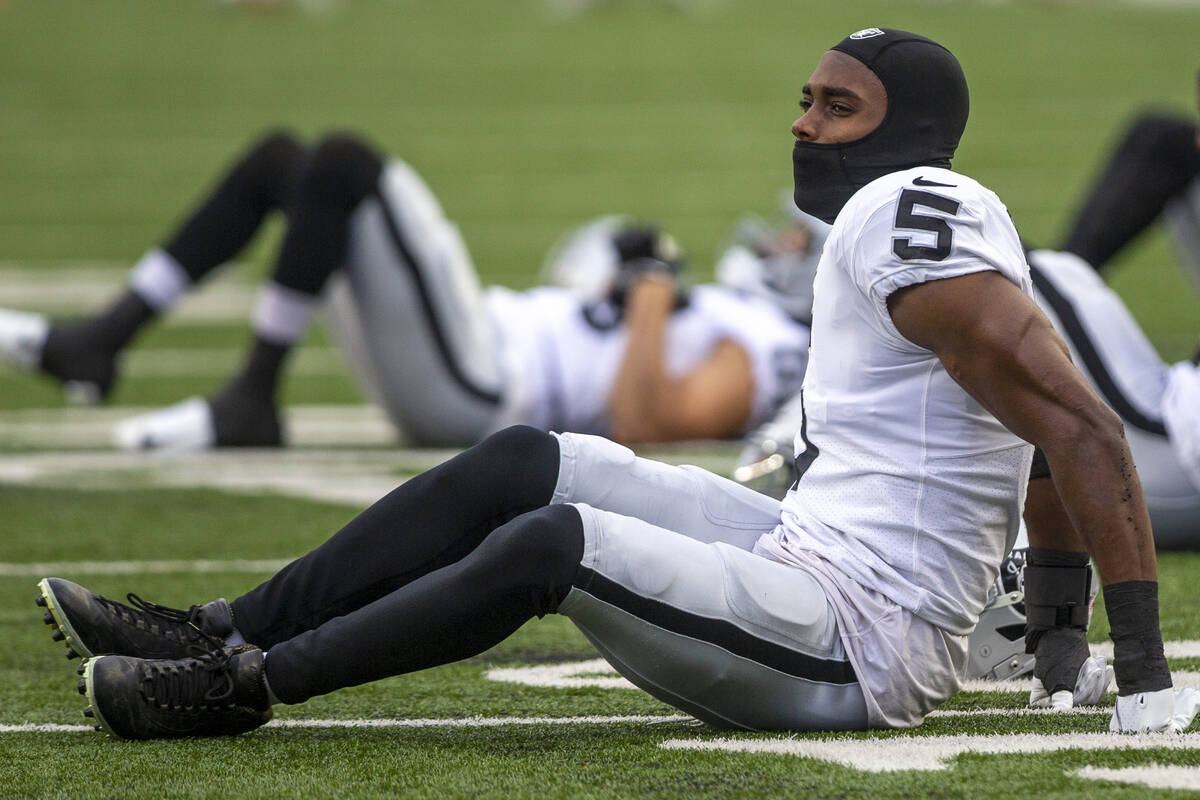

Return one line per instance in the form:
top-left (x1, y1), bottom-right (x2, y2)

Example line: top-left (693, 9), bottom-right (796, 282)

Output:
top-left (575, 567), bottom-right (858, 685)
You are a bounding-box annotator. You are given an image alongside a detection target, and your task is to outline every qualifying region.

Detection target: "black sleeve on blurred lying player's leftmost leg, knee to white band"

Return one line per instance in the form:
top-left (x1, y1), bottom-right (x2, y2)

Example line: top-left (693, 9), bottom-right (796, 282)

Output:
top-left (163, 132), bottom-right (306, 282)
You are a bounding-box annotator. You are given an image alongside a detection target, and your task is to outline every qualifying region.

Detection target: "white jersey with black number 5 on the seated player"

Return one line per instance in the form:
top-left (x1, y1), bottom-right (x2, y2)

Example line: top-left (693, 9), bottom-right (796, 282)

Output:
top-left (756, 167), bottom-right (1033, 727)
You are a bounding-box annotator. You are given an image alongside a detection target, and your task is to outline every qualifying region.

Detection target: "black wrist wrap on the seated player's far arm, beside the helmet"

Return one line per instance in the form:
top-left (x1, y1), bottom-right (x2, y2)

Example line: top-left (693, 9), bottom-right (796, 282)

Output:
top-left (1025, 547), bottom-right (1092, 652)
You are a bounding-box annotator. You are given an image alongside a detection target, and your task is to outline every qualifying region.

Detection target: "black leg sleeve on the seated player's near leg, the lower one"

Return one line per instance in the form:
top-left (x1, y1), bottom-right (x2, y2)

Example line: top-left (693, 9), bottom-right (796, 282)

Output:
top-left (266, 505), bottom-right (583, 703)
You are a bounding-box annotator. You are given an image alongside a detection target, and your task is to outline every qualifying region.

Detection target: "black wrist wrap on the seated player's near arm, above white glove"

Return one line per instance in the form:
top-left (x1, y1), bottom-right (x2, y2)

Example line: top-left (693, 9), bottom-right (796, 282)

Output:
top-left (1104, 581), bottom-right (1171, 694)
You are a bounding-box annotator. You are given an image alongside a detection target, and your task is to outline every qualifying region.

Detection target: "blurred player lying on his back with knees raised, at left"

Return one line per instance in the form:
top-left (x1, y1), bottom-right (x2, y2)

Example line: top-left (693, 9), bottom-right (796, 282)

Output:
top-left (0, 133), bottom-right (811, 449)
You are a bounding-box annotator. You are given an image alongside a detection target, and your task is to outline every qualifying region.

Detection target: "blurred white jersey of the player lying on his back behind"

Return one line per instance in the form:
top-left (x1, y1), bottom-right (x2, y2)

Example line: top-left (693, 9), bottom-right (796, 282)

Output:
top-left (485, 285), bottom-right (809, 434)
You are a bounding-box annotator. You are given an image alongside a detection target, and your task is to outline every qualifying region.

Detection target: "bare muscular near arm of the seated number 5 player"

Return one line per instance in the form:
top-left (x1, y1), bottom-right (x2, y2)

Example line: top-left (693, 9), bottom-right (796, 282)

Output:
top-left (888, 271), bottom-right (1157, 585)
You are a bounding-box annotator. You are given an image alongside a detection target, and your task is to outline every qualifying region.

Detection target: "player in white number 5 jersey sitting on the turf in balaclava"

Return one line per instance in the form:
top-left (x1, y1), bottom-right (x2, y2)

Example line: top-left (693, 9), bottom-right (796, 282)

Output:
top-left (38, 29), bottom-right (1195, 739)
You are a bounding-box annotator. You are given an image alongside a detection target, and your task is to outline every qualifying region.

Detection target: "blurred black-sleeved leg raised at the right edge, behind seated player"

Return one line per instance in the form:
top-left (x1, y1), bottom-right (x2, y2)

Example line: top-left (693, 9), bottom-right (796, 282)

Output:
top-left (1062, 114), bottom-right (1200, 270)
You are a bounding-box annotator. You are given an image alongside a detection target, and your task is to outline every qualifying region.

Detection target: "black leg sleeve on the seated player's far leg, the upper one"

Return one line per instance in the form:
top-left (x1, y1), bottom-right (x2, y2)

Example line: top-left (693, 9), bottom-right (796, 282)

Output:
top-left (233, 426), bottom-right (558, 649)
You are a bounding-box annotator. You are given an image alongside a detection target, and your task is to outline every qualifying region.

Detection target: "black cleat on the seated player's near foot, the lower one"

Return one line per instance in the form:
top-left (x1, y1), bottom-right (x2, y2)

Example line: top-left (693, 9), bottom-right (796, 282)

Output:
top-left (84, 645), bottom-right (271, 739)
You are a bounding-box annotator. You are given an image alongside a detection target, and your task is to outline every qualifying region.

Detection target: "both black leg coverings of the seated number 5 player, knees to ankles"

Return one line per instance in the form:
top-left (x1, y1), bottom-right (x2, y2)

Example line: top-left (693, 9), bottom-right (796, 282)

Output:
top-left (226, 426), bottom-right (583, 703)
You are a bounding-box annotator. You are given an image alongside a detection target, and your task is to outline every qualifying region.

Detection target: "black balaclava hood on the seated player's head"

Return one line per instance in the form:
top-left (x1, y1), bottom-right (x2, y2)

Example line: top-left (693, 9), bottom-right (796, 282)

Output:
top-left (792, 28), bottom-right (970, 223)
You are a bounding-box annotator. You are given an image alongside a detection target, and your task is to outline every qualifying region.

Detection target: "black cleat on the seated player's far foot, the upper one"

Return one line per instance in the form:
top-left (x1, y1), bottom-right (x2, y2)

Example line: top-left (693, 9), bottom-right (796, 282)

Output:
top-left (37, 578), bottom-right (233, 658)
